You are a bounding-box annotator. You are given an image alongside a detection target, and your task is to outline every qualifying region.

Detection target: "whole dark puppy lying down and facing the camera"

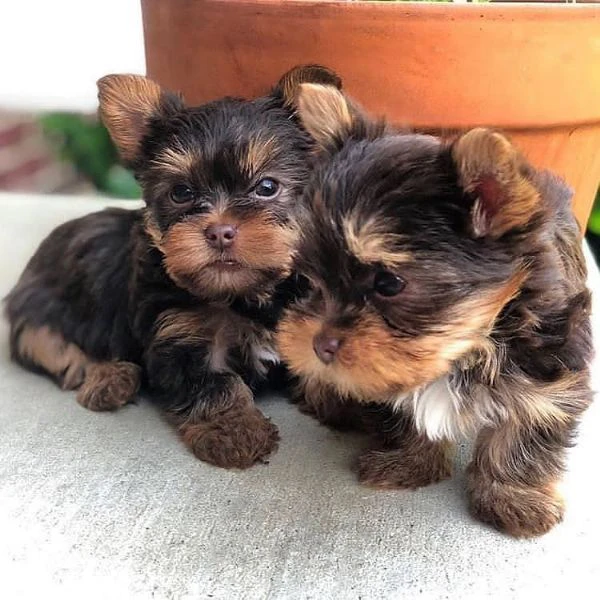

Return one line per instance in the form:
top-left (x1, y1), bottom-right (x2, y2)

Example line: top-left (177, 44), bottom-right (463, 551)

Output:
top-left (6, 65), bottom-right (341, 468)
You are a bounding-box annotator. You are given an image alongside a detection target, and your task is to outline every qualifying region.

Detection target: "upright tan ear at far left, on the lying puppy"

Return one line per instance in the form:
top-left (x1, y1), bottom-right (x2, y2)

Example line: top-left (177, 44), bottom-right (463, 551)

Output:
top-left (96, 75), bottom-right (183, 162)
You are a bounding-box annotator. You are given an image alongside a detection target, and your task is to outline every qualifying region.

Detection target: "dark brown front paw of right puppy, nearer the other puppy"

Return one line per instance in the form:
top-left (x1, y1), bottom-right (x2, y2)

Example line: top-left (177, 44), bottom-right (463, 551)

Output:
top-left (358, 449), bottom-right (452, 489)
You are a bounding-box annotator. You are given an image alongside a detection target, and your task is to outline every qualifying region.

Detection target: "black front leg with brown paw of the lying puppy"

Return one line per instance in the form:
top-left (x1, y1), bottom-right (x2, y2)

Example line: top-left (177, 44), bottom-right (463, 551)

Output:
top-left (146, 338), bottom-right (279, 469)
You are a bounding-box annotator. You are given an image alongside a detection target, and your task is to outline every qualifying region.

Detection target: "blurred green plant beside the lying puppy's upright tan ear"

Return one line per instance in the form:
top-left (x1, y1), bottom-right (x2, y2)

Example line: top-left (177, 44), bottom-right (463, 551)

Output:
top-left (40, 113), bottom-right (141, 198)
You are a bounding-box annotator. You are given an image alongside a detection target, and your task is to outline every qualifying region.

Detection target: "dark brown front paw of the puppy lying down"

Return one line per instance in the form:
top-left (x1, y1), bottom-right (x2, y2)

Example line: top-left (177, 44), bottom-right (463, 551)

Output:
top-left (181, 406), bottom-right (279, 469)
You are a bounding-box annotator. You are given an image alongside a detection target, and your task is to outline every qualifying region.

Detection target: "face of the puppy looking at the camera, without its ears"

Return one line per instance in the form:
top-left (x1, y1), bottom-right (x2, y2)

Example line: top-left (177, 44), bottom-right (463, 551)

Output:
top-left (139, 100), bottom-right (308, 296)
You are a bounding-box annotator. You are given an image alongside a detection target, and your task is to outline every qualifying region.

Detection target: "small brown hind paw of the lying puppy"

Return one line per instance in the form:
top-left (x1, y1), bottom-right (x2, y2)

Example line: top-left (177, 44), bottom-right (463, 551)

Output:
top-left (77, 361), bottom-right (141, 411)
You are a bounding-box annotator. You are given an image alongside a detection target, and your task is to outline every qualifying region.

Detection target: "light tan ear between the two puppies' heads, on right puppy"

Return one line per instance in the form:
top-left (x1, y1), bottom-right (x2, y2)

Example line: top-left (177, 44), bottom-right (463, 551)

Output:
top-left (297, 83), bottom-right (353, 148)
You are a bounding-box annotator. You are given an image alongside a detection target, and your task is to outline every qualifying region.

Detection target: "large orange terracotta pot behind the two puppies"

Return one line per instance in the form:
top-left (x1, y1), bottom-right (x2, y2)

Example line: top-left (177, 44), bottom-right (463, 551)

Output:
top-left (142, 0), bottom-right (600, 224)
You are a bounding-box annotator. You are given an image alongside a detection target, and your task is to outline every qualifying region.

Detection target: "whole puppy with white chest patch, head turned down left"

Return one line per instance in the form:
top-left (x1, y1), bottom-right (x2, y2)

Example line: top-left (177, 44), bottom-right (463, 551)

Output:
top-left (277, 84), bottom-right (592, 536)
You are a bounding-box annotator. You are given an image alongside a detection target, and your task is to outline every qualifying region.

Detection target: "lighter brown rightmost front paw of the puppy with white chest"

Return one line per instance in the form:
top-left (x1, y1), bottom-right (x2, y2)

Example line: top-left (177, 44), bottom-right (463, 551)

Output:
top-left (469, 480), bottom-right (564, 538)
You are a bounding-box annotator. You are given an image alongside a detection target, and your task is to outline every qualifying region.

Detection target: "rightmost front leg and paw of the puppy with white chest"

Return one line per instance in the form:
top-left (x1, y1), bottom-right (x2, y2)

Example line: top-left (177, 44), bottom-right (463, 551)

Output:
top-left (467, 423), bottom-right (574, 537)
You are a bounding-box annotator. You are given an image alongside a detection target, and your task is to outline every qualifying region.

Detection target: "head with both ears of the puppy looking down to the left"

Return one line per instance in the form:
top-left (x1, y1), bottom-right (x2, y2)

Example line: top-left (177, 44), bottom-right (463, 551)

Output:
top-left (278, 86), bottom-right (542, 400)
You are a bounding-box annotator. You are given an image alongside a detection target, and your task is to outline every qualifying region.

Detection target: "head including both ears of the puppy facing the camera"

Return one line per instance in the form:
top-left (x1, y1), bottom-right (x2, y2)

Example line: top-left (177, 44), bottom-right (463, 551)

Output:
top-left (99, 66), bottom-right (339, 297)
